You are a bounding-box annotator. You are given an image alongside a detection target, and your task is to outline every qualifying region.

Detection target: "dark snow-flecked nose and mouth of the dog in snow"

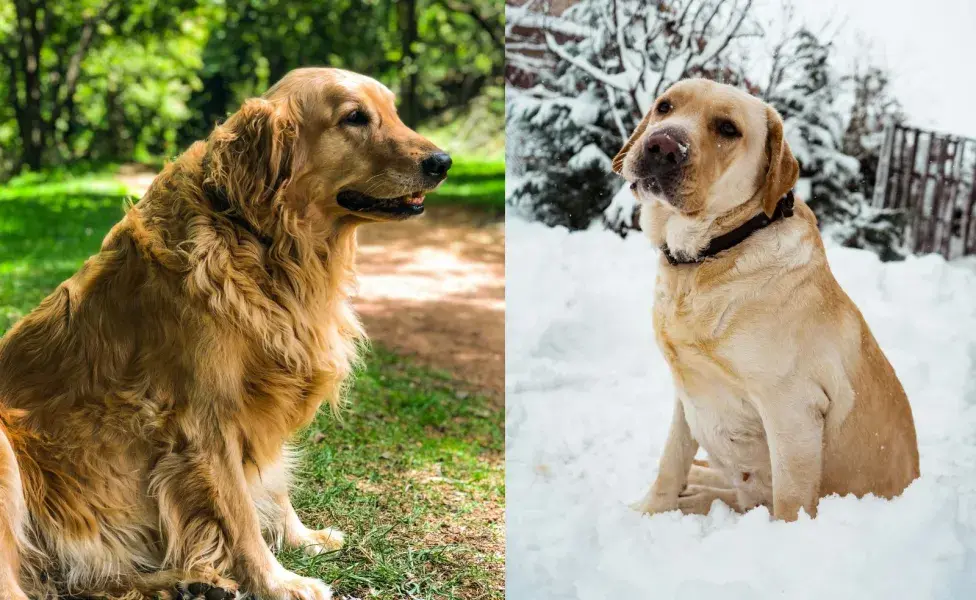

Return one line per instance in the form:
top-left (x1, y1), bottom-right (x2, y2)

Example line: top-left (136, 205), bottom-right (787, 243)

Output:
top-left (631, 127), bottom-right (691, 208)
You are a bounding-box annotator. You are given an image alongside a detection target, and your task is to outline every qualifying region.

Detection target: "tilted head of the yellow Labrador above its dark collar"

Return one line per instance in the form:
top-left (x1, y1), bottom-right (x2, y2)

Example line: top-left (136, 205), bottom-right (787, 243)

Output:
top-left (613, 79), bottom-right (799, 216)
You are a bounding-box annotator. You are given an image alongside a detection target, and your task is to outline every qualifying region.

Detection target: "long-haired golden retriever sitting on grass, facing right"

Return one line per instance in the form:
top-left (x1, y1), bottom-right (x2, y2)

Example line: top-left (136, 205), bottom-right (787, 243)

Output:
top-left (0, 68), bottom-right (451, 600)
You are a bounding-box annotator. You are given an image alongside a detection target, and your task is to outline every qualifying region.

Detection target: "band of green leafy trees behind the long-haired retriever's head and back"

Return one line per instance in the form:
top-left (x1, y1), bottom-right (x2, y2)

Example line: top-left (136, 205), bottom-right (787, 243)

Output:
top-left (0, 0), bottom-right (504, 176)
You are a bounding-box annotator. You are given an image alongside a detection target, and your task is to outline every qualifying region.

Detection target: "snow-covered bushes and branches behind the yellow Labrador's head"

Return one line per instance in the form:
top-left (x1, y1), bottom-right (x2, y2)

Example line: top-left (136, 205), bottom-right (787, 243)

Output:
top-left (506, 0), bottom-right (903, 257)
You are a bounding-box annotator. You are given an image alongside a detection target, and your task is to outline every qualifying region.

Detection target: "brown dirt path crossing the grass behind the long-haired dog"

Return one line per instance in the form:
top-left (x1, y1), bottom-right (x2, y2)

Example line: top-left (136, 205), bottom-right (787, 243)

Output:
top-left (117, 165), bottom-right (505, 401)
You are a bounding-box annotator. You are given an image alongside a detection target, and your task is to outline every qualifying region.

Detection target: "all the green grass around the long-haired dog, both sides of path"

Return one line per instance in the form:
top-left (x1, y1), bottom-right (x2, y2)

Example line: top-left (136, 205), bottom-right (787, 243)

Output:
top-left (0, 171), bottom-right (505, 600)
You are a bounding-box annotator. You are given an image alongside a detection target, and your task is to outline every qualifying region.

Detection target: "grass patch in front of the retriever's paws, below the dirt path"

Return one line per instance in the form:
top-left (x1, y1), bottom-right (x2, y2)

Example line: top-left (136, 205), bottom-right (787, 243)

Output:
top-left (283, 349), bottom-right (505, 599)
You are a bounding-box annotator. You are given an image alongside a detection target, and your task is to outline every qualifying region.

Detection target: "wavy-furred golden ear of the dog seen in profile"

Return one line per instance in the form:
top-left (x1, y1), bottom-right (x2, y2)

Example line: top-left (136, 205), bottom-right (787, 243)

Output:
top-left (204, 98), bottom-right (298, 213)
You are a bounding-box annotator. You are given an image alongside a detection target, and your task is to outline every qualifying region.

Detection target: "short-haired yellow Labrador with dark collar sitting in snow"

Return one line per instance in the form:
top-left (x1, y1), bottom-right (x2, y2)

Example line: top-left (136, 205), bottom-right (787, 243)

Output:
top-left (613, 79), bottom-right (919, 521)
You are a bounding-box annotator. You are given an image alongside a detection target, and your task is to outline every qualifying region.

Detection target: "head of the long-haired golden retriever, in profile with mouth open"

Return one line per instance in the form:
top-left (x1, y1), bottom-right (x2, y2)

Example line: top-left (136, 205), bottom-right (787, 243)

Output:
top-left (204, 68), bottom-right (451, 229)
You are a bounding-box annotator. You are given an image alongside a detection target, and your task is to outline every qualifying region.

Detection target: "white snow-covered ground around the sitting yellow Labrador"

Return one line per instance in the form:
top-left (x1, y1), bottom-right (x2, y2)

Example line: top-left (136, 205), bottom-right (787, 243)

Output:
top-left (506, 217), bottom-right (976, 600)
